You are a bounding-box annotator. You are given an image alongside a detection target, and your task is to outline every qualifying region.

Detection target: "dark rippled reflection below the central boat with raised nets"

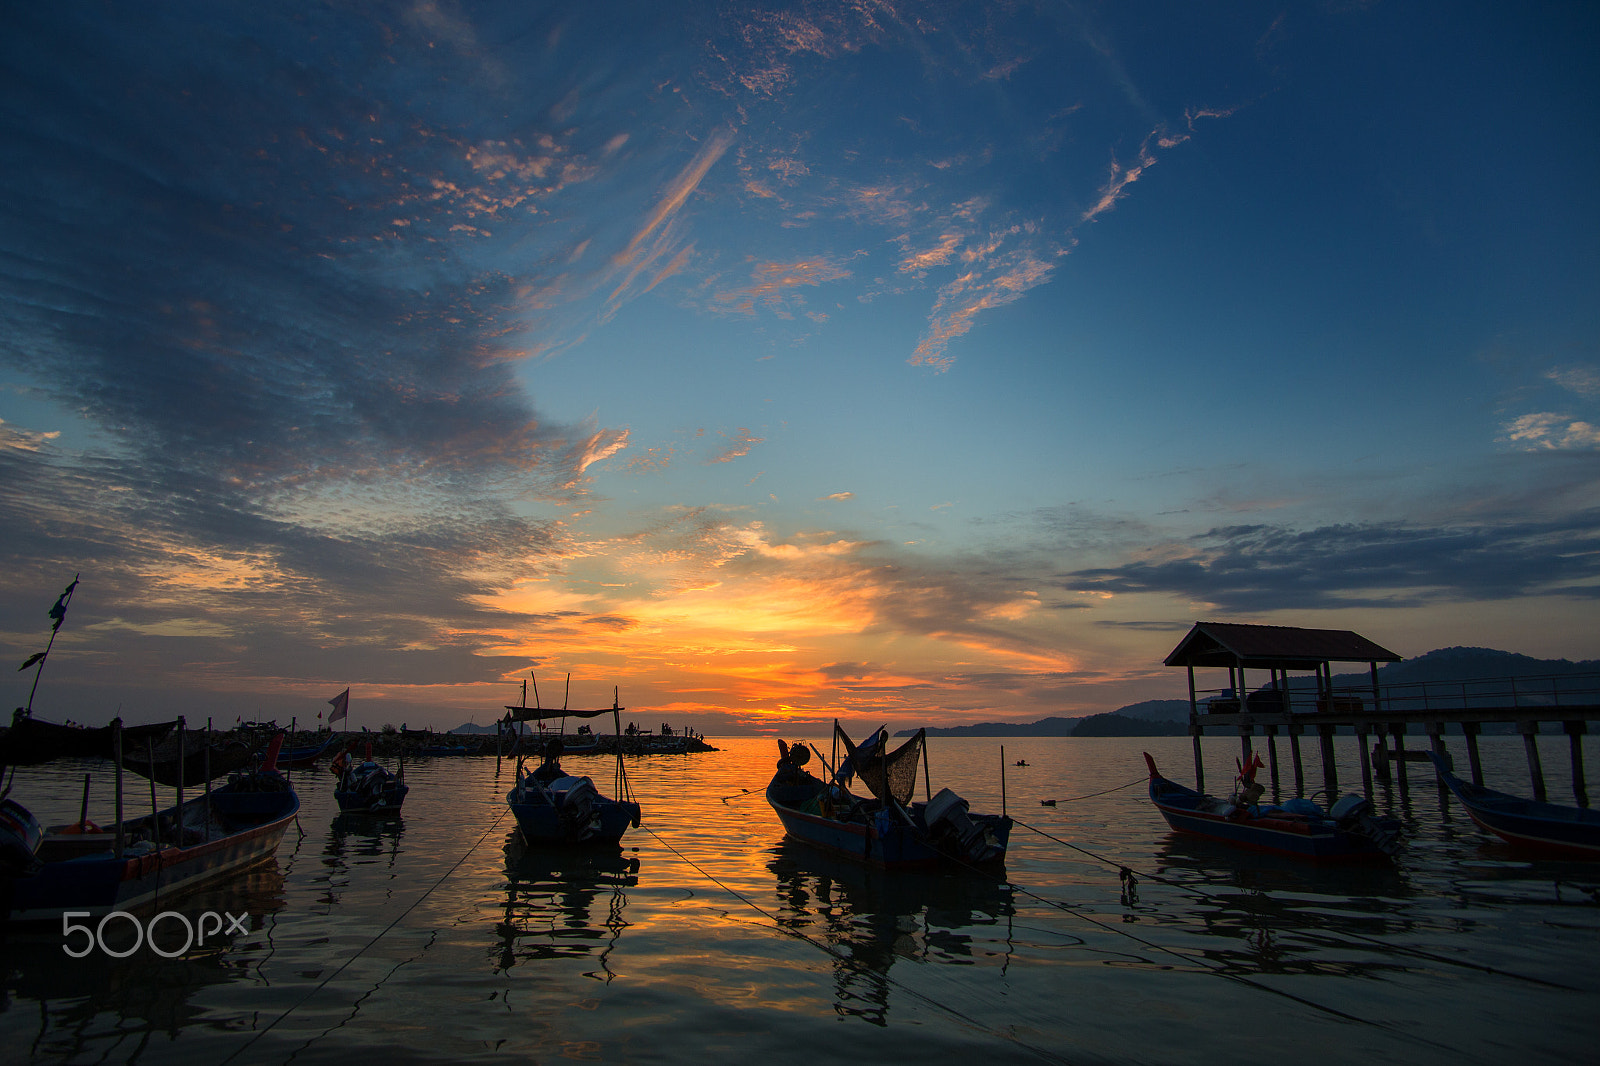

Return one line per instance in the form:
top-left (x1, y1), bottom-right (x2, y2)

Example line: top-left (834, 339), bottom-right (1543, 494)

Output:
top-left (766, 840), bottom-right (1014, 1026)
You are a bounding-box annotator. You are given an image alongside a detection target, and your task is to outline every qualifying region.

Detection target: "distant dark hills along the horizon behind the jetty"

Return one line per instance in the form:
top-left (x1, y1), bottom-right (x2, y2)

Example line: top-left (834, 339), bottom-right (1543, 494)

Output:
top-left (896, 647), bottom-right (1600, 736)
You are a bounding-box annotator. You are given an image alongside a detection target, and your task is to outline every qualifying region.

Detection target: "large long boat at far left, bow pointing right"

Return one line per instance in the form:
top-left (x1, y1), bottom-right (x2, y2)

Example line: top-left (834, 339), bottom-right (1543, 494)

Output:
top-left (0, 723), bottom-right (299, 925)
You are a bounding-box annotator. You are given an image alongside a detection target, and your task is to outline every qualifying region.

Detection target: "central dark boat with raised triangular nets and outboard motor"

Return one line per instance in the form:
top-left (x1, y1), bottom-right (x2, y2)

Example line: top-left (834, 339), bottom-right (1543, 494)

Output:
top-left (766, 722), bottom-right (1011, 869)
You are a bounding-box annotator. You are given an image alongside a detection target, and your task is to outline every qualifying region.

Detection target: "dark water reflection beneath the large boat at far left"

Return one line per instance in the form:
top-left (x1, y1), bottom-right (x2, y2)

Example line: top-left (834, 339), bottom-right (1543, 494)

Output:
top-left (0, 860), bottom-right (285, 1063)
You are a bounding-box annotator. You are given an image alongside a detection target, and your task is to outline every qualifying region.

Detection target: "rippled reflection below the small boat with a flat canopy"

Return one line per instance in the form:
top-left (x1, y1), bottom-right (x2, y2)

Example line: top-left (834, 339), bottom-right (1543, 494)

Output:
top-left (493, 832), bottom-right (638, 983)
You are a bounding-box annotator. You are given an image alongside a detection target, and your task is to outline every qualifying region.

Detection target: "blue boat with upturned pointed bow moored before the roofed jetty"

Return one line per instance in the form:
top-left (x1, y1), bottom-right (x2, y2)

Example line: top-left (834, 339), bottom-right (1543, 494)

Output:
top-left (1144, 752), bottom-right (1400, 861)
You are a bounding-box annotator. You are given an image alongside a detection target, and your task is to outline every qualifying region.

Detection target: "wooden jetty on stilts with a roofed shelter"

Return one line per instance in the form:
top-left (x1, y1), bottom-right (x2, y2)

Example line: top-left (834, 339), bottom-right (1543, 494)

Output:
top-left (1165, 623), bottom-right (1600, 807)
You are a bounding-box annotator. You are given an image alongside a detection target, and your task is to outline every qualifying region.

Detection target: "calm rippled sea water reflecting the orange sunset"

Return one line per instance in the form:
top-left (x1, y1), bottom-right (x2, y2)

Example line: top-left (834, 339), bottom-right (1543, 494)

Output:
top-left (0, 738), bottom-right (1600, 1066)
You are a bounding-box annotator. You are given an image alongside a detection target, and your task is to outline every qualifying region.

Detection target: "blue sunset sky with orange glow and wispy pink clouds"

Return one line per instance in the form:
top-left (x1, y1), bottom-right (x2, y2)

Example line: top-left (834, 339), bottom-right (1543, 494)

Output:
top-left (0, 0), bottom-right (1600, 735)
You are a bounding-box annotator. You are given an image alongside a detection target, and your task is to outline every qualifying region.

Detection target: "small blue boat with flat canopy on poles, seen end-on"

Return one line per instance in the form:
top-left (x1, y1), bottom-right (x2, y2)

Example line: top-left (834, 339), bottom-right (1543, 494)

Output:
top-left (506, 688), bottom-right (643, 845)
